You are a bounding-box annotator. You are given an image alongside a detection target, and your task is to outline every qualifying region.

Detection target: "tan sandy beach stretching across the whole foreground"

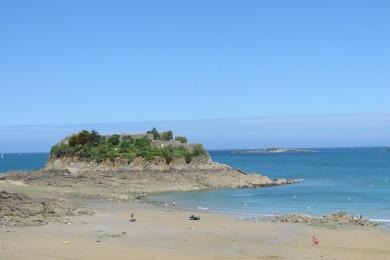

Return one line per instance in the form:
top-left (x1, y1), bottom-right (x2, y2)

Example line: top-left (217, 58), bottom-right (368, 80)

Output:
top-left (0, 196), bottom-right (390, 260)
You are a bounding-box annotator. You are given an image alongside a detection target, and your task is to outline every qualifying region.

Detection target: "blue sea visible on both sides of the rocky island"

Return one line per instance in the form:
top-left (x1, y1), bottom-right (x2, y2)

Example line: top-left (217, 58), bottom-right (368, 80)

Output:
top-left (0, 147), bottom-right (390, 221)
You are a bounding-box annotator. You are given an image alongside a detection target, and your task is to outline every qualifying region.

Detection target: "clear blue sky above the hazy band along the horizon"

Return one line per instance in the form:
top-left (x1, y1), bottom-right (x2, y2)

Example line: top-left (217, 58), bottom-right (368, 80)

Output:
top-left (0, 0), bottom-right (390, 149)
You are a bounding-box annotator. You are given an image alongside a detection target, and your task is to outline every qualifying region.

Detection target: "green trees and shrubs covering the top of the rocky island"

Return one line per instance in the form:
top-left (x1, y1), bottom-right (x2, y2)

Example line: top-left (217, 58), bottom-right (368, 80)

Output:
top-left (50, 128), bottom-right (207, 163)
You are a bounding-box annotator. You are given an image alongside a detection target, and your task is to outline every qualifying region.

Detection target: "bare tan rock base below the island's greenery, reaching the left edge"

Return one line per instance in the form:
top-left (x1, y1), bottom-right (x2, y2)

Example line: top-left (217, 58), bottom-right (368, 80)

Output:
top-left (1, 162), bottom-right (296, 204)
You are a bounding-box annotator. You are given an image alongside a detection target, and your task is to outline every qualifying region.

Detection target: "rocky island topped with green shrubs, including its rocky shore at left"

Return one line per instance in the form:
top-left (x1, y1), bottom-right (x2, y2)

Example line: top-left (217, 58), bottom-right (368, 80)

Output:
top-left (0, 128), bottom-right (296, 225)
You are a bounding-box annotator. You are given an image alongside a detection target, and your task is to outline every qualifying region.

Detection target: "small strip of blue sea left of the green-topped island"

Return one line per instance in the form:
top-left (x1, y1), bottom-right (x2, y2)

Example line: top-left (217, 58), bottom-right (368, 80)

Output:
top-left (0, 153), bottom-right (49, 173)
